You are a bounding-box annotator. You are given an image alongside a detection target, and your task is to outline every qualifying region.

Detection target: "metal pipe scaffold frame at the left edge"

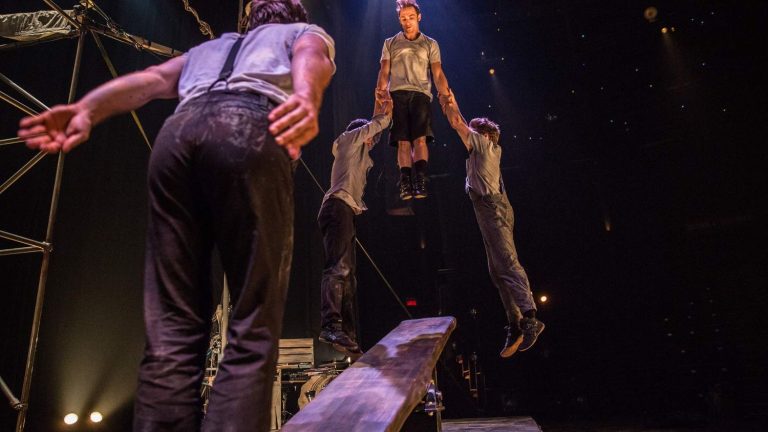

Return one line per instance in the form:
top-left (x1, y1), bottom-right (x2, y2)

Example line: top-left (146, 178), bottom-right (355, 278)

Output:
top-left (0, 0), bottom-right (181, 432)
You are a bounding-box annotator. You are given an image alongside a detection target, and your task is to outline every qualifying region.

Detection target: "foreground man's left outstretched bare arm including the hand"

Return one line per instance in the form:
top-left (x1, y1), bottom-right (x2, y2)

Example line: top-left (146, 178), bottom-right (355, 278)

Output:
top-left (18, 57), bottom-right (186, 153)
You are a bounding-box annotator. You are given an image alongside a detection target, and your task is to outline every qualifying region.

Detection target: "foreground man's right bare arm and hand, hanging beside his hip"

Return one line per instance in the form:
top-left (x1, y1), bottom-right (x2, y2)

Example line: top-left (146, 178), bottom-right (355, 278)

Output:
top-left (269, 34), bottom-right (333, 159)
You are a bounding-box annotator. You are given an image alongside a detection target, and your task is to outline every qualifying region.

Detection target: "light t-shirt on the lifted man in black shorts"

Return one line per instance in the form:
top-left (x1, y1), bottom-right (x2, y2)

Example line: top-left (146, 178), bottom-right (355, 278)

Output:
top-left (381, 32), bottom-right (440, 100)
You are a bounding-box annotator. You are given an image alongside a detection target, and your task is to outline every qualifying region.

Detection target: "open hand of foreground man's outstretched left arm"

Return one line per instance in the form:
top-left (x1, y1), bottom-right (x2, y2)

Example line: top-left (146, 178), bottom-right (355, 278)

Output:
top-left (18, 104), bottom-right (93, 153)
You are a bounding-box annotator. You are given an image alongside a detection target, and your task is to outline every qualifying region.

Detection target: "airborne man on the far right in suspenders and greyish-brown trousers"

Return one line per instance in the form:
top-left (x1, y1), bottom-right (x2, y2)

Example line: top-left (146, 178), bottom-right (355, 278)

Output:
top-left (440, 90), bottom-right (545, 358)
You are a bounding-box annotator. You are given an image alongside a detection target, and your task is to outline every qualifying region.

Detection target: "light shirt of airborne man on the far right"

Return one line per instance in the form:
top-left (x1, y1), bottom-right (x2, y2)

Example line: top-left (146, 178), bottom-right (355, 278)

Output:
top-left (464, 130), bottom-right (504, 195)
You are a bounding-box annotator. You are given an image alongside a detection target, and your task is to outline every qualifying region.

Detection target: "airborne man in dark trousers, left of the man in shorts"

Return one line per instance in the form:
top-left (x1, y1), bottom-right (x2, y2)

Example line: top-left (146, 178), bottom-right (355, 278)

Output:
top-left (317, 100), bottom-right (392, 358)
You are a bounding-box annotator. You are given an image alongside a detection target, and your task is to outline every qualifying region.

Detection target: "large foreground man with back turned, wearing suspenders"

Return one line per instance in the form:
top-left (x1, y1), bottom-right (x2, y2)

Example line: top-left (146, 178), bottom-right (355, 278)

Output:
top-left (19, 0), bottom-right (335, 432)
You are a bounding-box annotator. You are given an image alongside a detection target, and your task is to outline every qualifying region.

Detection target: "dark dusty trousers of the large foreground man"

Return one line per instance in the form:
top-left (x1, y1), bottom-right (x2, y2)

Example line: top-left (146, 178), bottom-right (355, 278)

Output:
top-left (134, 92), bottom-right (294, 432)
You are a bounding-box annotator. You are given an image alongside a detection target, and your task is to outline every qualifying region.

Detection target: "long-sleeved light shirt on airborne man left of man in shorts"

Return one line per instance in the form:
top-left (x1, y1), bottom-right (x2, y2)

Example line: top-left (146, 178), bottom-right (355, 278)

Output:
top-left (323, 114), bottom-right (391, 214)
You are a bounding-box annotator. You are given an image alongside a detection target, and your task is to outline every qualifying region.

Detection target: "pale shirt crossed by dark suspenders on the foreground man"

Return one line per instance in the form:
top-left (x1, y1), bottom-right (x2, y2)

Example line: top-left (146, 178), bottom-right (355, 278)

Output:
top-left (182, 23), bottom-right (335, 110)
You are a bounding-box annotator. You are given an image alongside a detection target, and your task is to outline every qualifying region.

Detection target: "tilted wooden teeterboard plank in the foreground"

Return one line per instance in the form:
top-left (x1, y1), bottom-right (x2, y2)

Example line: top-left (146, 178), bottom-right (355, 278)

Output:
top-left (282, 317), bottom-right (456, 432)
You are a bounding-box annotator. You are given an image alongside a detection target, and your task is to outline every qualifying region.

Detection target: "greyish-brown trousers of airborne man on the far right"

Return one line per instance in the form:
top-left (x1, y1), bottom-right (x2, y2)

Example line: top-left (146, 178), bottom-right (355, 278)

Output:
top-left (469, 191), bottom-right (536, 323)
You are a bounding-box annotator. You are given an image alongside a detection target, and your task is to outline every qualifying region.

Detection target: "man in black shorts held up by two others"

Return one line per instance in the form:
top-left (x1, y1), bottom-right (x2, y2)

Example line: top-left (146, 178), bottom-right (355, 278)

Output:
top-left (376, 0), bottom-right (448, 200)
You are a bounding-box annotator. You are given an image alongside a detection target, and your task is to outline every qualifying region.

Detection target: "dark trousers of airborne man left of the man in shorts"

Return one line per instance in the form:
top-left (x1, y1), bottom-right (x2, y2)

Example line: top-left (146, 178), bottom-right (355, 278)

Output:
top-left (317, 198), bottom-right (357, 341)
